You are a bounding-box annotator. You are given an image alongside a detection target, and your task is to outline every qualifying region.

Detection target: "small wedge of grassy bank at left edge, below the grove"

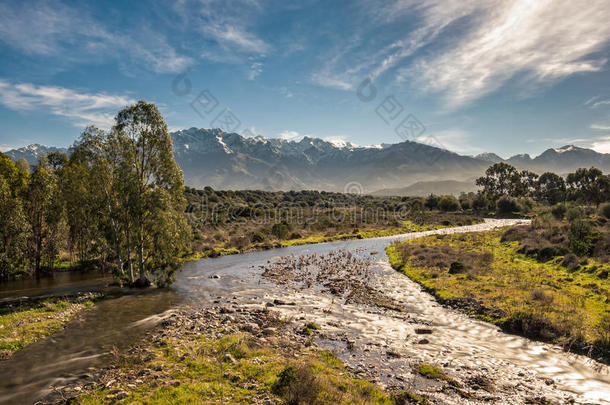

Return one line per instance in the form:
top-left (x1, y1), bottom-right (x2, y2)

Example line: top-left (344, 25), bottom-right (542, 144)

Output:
top-left (0, 294), bottom-right (99, 359)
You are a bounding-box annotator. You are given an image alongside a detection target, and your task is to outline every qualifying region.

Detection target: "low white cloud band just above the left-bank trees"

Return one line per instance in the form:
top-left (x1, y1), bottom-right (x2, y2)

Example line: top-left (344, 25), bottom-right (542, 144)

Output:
top-left (0, 80), bottom-right (135, 128)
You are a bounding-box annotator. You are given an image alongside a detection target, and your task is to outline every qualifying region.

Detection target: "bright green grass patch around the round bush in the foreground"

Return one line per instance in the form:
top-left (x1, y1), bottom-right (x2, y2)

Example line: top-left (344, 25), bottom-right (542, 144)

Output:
top-left (79, 333), bottom-right (393, 405)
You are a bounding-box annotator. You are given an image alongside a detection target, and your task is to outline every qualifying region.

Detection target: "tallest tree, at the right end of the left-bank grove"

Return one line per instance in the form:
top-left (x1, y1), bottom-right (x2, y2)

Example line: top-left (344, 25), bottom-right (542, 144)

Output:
top-left (111, 101), bottom-right (189, 283)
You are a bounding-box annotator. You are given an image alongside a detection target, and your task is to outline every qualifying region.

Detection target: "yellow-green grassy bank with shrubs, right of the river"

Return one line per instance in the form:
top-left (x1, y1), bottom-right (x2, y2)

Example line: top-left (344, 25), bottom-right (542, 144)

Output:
top-left (387, 231), bottom-right (610, 362)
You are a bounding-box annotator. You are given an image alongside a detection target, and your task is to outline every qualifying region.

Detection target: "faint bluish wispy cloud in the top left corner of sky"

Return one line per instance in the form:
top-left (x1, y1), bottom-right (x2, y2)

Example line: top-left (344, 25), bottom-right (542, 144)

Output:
top-left (0, 1), bottom-right (193, 73)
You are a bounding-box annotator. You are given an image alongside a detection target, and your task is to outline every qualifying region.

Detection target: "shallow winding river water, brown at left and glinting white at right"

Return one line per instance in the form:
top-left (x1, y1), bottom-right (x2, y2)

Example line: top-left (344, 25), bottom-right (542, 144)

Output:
top-left (0, 220), bottom-right (610, 404)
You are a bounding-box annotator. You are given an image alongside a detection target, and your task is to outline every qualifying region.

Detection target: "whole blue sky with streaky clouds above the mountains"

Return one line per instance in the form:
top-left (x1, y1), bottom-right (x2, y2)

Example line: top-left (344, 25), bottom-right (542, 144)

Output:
top-left (0, 0), bottom-right (610, 158)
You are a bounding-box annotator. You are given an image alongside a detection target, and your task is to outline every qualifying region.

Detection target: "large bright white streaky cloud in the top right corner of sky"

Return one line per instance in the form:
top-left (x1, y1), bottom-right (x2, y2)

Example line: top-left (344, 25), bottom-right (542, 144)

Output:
top-left (403, 0), bottom-right (610, 106)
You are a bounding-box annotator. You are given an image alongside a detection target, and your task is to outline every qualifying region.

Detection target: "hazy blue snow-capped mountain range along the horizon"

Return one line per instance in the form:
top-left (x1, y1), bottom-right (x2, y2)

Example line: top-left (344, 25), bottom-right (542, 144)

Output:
top-left (5, 128), bottom-right (610, 195)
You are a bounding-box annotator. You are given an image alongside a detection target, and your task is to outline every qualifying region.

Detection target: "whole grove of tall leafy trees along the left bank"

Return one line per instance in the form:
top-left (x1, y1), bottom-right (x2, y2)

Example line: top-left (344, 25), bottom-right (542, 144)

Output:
top-left (0, 101), bottom-right (191, 285)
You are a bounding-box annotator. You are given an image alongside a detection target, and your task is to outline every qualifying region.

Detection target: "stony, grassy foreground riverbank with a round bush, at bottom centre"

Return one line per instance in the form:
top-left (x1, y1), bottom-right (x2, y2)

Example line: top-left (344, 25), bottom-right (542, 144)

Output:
top-left (54, 305), bottom-right (404, 405)
